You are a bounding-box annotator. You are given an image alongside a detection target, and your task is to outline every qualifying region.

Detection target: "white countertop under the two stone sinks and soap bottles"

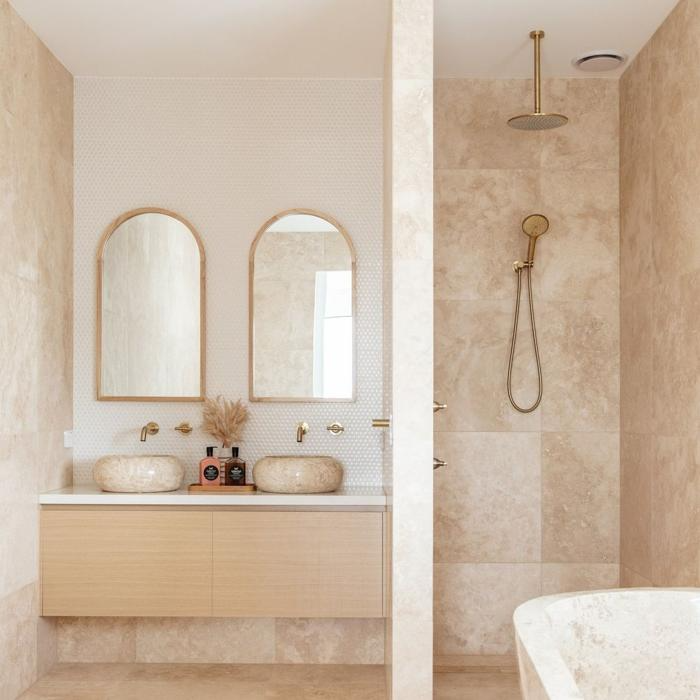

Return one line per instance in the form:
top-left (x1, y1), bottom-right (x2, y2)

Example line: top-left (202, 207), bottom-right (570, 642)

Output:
top-left (39, 484), bottom-right (387, 507)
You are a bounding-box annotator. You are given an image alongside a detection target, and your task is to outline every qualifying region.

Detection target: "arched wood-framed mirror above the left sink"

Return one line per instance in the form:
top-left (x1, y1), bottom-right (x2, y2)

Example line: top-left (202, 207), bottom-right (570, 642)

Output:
top-left (97, 209), bottom-right (205, 401)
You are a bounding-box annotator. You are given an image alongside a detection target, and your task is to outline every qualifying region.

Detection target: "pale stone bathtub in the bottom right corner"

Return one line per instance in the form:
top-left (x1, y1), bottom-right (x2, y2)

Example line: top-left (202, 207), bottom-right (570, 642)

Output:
top-left (513, 588), bottom-right (700, 700)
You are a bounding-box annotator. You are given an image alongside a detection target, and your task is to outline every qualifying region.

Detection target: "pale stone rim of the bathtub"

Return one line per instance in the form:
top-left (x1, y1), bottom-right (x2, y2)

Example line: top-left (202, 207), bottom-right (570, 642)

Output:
top-left (513, 587), bottom-right (700, 700)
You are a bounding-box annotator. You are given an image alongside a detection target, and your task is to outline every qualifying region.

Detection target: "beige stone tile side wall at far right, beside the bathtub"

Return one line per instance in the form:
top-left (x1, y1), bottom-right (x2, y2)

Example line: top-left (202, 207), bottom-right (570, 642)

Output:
top-left (620, 0), bottom-right (700, 586)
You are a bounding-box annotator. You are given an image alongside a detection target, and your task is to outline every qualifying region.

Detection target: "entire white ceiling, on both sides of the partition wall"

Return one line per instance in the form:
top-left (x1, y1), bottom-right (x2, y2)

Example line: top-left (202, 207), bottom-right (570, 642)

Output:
top-left (11, 0), bottom-right (677, 78)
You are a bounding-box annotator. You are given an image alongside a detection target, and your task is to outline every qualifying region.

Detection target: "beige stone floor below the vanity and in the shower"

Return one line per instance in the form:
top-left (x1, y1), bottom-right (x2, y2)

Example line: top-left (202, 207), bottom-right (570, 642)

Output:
top-left (21, 664), bottom-right (520, 700)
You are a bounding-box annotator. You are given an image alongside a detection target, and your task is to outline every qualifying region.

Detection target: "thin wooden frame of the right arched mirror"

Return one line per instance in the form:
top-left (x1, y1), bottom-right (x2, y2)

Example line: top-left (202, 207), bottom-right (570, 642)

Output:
top-left (248, 209), bottom-right (357, 403)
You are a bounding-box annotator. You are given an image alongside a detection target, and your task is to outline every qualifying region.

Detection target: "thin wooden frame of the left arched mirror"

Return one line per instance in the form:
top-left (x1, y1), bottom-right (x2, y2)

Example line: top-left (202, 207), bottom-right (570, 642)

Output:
top-left (95, 207), bottom-right (207, 403)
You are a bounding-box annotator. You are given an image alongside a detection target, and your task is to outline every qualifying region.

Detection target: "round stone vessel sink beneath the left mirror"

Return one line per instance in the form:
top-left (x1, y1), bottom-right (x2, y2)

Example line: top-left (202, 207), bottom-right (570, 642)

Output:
top-left (92, 455), bottom-right (185, 493)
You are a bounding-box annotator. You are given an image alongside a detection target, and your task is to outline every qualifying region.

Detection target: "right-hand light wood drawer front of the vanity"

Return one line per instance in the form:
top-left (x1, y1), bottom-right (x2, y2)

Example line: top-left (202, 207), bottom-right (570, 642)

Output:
top-left (213, 512), bottom-right (384, 617)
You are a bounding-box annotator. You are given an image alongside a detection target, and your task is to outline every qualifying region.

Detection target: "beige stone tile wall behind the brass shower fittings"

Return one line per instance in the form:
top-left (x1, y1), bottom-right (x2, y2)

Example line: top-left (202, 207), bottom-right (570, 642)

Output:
top-left (435, 79), bottom-right (620, 658)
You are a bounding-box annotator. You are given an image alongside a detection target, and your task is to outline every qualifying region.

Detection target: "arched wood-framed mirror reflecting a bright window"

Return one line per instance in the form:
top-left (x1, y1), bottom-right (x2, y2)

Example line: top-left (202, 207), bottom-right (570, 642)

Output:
top-left (250, 209), bottom-right (356, 401)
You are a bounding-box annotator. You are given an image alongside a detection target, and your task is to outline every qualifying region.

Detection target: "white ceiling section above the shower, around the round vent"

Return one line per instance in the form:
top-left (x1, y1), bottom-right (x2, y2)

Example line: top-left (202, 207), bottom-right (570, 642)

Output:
top-left (435, 0), bottom-right (677, 78)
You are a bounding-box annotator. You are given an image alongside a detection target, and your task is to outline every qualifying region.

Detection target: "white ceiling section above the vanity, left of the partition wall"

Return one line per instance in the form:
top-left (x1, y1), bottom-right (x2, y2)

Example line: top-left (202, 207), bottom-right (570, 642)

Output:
top-left (10, 0), bottom-right (389, 78)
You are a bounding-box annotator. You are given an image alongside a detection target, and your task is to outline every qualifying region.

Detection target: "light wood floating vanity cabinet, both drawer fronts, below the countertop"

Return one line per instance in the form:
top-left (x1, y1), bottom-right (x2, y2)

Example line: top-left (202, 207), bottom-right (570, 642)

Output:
top-left (41, 506), bottom-right (384, 617)
